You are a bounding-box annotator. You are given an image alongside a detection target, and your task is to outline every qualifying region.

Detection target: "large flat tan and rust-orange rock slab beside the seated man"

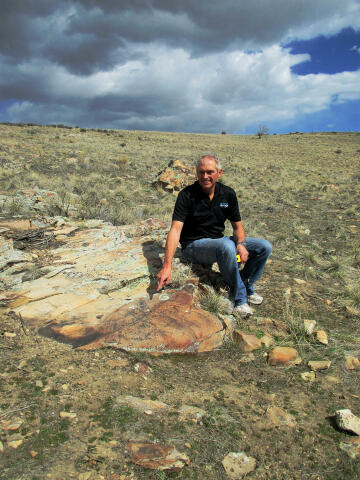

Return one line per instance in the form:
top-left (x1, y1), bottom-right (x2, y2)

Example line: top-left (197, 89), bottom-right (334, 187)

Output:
top-left (0, 219), bottom-right (225, 353)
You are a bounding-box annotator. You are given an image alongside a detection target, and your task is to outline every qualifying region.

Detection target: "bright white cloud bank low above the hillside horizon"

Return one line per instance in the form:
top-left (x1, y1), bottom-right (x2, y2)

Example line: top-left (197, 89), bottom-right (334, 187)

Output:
top-left (5, 44), bottom-right (360, 132)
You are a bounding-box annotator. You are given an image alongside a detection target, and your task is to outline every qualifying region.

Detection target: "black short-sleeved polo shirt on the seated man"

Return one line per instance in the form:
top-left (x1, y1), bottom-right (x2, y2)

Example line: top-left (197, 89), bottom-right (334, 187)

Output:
top-left (172, 181), bottom-right (241, 248)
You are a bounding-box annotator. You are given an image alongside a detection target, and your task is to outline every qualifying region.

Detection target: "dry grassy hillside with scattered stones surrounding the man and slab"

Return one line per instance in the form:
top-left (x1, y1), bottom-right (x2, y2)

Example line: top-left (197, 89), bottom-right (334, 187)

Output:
top-left (0, 124), bottom-right (360, 480)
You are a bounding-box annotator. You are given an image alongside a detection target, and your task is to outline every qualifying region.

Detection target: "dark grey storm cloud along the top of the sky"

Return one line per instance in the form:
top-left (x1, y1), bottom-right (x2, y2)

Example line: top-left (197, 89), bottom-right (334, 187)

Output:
top-left (0, 0), bottom-right (354, 75)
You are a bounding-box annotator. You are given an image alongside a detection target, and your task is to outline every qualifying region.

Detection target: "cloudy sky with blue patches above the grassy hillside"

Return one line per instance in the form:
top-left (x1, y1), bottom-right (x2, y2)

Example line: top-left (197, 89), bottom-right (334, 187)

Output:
top-left (0, 0), bottom-right (360, 134)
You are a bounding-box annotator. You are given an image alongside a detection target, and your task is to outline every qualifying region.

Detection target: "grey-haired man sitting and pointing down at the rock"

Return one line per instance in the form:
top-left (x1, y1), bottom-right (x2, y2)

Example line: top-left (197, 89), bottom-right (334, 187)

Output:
top-left (157, 155), bottom-right (271, 317)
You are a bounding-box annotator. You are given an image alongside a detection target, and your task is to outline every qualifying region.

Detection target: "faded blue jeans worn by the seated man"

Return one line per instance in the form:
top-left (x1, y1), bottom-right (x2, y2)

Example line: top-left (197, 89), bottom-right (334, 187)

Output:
top-left (183, 237), bottom-right (272, 305)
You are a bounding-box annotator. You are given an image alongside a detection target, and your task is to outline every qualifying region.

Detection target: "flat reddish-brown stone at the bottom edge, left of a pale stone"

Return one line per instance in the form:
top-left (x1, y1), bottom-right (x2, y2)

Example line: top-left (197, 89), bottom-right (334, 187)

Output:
top-left (128, 443), bottom-right (190, 472)
